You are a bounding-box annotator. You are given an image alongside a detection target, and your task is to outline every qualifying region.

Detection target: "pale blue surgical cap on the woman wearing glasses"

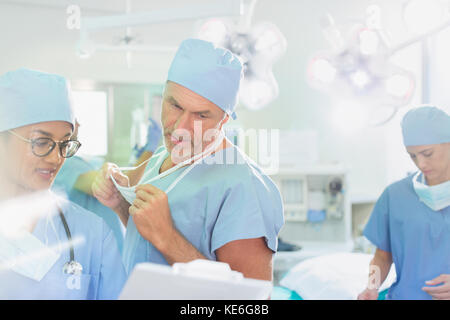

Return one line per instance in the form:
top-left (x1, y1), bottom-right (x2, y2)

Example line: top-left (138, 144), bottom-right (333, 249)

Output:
top-left (0, 69), bottom-right (75, 132)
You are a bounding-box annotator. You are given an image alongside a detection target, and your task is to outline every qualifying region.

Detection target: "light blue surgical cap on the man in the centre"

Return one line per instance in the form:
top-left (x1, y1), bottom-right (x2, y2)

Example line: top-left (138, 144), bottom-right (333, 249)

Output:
top-left (167, 39), bottom-right (243, 119)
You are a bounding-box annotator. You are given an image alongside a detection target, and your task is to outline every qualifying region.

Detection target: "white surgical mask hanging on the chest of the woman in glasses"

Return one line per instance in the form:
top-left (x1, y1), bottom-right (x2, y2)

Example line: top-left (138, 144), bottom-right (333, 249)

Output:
top-left (0, 216), bottom-right (60, 281)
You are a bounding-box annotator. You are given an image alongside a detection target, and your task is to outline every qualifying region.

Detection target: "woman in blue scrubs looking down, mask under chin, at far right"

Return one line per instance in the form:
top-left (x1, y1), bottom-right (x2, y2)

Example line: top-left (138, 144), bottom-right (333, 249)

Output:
top-left (358, 106), bottom-right (450, 300)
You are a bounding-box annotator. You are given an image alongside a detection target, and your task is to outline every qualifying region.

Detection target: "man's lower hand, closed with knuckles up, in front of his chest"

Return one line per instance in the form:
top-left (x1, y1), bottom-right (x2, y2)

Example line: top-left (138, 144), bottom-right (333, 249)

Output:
top-left (129, 184), bottom-right (176, 250)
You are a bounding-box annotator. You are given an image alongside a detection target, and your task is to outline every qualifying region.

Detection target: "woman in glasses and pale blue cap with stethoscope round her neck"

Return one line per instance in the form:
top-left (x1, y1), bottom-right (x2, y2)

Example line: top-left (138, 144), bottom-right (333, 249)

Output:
top-left (0, 69), bottom-right (126, 299)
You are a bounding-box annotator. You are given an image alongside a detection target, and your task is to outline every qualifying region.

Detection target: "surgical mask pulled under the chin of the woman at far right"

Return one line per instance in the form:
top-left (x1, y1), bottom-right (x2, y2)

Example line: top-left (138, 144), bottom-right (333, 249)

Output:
top-left (413, 171), bottom-right (450, 211)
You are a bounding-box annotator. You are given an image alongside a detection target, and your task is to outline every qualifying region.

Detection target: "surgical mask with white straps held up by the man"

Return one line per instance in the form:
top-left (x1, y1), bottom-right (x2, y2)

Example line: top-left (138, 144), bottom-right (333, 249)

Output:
top-left (110, 114), bottom-right (226, 204)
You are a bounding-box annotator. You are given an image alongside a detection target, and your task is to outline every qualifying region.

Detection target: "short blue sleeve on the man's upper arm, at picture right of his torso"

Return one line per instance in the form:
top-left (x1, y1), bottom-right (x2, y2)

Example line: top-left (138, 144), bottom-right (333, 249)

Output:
top-left (211, 175), bottom-right (283, 256)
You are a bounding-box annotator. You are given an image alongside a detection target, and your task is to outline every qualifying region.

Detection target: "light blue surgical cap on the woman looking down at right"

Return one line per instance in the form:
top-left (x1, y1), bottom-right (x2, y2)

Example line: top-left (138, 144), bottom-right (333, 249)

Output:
top-left (401, 106), bottom-right (450, 147)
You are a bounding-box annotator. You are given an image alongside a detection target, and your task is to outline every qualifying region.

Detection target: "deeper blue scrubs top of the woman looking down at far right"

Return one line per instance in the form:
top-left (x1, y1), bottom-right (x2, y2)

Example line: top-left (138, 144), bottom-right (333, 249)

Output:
top-left (363, 172), bottom-right (450, 300)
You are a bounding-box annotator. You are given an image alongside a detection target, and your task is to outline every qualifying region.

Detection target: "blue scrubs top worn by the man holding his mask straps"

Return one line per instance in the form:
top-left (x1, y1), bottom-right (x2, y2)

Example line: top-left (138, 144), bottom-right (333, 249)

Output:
top-left (123, 146), bottom-right (284, 272)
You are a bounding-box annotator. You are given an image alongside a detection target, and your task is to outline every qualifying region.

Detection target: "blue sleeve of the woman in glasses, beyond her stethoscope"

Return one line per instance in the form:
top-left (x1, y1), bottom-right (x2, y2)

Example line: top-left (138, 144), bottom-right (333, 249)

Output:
top-left (97, 221), bottom-right (127, 300)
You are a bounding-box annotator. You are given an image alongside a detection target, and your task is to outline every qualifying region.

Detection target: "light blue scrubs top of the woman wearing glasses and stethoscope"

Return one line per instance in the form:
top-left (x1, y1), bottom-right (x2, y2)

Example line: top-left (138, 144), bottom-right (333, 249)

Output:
top-left (0, 200), bottom-right (126, 300)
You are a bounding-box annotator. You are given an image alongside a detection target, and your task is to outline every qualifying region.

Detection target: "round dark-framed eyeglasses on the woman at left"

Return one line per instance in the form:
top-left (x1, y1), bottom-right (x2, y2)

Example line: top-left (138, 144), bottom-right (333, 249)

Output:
top-left (8, 130), bottom-right (81, 158)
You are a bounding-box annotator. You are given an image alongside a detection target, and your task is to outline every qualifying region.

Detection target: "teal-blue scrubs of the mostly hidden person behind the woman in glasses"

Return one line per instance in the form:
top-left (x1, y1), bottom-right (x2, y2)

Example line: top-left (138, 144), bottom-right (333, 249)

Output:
top-left (52, 156), bottom-right (124, 252)
